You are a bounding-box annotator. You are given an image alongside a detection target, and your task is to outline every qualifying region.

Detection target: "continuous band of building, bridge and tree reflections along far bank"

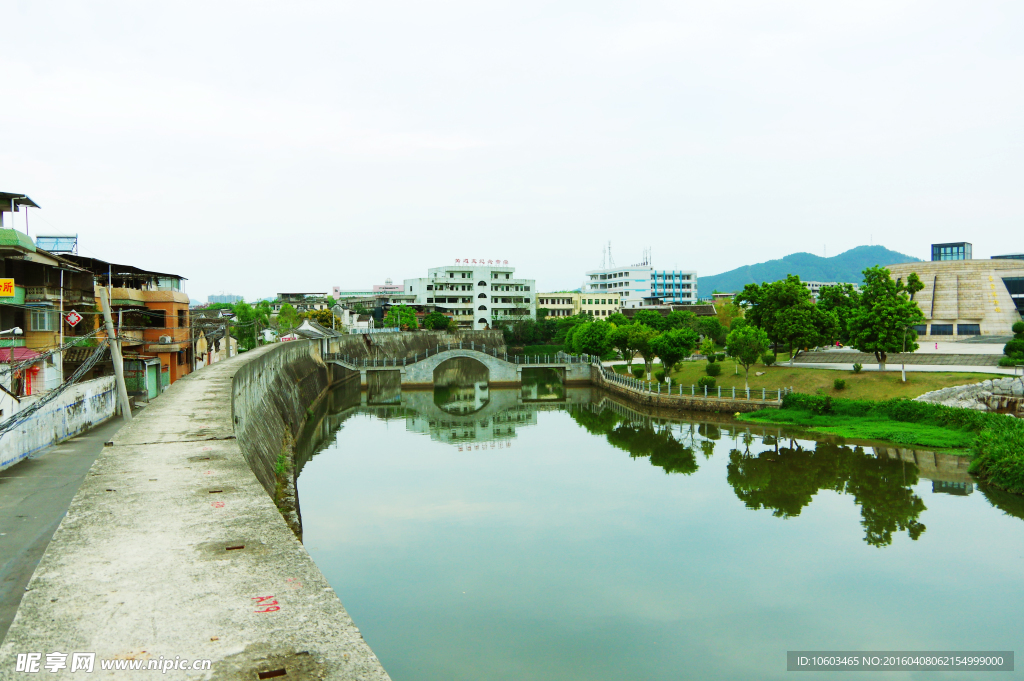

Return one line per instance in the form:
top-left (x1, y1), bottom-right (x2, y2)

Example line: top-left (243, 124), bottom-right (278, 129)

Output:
top-left (298, 376), bottom-right (999, 547)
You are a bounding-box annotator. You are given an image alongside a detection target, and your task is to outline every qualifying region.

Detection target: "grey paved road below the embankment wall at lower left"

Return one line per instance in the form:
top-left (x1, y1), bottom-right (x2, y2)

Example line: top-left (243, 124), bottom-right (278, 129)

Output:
top-left (0, 417), bottom-right (124, 640)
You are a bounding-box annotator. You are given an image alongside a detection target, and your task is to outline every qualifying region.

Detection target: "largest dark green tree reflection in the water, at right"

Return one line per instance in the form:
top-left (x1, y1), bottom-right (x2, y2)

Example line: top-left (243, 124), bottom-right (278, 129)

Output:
top-left (727, 442), bottom-right (926, 547)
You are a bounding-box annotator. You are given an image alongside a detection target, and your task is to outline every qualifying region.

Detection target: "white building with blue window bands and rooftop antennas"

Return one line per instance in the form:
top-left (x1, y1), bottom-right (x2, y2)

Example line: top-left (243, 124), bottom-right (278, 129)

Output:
top-left (581, 264), bottom-right (697, 307)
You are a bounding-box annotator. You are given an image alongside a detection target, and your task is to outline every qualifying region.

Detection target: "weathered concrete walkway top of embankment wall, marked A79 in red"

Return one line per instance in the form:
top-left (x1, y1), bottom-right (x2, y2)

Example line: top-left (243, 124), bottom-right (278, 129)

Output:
top-left (0, 344), bottom-right (388, 680)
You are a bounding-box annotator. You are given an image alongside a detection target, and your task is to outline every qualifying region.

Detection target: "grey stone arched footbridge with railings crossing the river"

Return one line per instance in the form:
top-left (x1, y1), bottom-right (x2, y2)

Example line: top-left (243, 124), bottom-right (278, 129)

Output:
top-left (324, 345), bottom-right (592, 388)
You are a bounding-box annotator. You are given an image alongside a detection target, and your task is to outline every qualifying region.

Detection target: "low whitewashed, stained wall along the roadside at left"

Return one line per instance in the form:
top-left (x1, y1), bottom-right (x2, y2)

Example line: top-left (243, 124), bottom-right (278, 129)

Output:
top-left (0, 376), bottom-right (117, 470)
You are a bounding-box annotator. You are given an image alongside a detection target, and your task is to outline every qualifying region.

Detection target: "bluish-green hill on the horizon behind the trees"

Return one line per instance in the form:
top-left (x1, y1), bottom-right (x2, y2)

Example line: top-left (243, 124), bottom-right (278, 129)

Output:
top-left (697, 246), bottom-right (921, 298)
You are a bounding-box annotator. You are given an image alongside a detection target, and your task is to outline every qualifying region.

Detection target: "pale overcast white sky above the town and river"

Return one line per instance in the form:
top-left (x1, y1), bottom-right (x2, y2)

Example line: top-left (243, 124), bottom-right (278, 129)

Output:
top-left (0, 0), bottom-right (1024, 301)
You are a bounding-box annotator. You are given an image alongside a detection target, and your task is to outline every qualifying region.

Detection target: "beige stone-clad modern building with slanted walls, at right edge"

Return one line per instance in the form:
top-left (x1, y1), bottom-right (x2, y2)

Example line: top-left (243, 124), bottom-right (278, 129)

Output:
top-left (888, 251), bottom-right (1024, 341)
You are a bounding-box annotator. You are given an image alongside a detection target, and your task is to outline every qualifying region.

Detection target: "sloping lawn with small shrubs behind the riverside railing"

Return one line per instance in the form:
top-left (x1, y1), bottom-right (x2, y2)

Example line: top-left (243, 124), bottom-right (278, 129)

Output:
top-left (615, 359), bottom-right (1001, 400)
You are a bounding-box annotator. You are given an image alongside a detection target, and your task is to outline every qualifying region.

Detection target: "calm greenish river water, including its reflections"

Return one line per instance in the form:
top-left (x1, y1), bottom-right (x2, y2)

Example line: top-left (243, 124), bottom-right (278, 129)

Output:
top-left (298, 358), bottom-right (1024, 681)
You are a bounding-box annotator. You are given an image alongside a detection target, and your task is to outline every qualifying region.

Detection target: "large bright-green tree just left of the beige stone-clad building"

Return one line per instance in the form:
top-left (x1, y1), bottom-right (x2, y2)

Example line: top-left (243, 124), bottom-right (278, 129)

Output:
top-left (850, 267), bottom-right (925, 371)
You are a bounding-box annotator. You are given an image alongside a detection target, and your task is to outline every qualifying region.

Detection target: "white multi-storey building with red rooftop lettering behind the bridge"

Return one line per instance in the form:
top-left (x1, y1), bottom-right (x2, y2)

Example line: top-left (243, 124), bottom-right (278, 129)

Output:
top-left (404, 261), bottom-right (537, 330)
